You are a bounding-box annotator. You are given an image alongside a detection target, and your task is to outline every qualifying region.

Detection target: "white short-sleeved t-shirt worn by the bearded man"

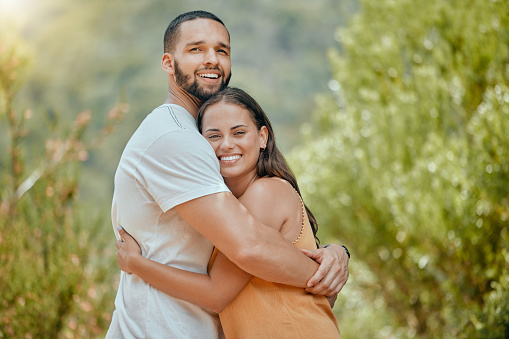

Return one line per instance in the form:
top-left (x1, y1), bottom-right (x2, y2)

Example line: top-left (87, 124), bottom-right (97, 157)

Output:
top-left (106, 104), bottom-right (228, 339)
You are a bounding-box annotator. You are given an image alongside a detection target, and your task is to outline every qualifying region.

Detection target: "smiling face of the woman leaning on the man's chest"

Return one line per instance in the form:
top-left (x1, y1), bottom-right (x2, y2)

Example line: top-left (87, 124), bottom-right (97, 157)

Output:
top-left (202, 102), bottom-right (267, 179)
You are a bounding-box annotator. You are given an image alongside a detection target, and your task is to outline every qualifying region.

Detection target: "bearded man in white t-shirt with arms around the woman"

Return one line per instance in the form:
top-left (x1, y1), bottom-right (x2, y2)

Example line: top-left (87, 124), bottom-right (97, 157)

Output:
top-left (107, 11), bottom-right (348, 338)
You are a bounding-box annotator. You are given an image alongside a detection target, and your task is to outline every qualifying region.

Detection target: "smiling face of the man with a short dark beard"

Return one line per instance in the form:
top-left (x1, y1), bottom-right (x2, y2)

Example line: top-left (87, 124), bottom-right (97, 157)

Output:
top-left (174, 19), bottom-right (231, 101)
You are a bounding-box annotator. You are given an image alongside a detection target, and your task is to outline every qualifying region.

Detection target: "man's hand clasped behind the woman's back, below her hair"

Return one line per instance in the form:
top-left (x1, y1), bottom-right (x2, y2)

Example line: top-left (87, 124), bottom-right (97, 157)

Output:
top-left (302, 244), bottom-right (349, 297)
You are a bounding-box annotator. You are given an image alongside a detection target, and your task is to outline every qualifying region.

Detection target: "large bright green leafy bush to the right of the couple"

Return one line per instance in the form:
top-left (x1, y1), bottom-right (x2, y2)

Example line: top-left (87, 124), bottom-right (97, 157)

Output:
top-left (293, 0), bottom-right (509, 338)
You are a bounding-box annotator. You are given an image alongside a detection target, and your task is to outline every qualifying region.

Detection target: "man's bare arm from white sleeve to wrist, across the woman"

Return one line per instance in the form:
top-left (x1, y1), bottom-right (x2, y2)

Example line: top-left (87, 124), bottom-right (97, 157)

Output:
top-left (175, 192), bottom-right (318, 287)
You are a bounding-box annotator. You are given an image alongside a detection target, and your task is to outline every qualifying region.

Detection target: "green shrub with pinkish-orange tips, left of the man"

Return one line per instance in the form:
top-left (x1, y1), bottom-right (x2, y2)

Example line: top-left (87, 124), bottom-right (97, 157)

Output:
top-left (0, 36), bottom-right (126, 338)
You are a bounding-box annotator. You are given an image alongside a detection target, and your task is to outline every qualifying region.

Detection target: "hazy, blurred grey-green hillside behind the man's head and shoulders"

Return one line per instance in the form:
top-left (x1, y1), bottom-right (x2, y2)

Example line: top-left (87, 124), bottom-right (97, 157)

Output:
top-left (0, 0), bottom-right (356, 206)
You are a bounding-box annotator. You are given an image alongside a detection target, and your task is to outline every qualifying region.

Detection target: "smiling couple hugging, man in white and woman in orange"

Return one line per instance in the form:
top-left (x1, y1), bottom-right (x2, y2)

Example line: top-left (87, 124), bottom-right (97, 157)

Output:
top-left (106, 11), bottom-right (349, 339)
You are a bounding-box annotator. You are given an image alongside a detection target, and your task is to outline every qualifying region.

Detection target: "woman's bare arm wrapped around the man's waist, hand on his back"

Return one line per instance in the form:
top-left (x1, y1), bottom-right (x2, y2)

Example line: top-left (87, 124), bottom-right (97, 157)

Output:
top-left (116, 229), bottom-right (252, 313)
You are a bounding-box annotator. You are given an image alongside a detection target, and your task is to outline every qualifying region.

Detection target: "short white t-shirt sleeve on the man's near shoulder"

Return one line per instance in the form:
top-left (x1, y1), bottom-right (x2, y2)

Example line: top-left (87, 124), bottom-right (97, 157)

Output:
top-left (136, 130), bottom-right (229, 212)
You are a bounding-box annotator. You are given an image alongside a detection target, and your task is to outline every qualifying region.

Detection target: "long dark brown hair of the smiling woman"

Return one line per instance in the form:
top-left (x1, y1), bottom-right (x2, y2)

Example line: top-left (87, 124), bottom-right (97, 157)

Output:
top-left (197, 87), bottom-right (319, 243)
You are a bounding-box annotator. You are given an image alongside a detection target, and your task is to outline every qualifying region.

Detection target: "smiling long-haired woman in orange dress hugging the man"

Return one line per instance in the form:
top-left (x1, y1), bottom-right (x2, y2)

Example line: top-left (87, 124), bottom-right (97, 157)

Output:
top-left (117, 88), bottom-right (340, 338)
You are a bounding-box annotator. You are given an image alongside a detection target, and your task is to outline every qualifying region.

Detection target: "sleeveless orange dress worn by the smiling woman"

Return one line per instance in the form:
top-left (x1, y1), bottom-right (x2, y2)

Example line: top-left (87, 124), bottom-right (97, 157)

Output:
top-left (209, 194), bottom-right (340, 339)
